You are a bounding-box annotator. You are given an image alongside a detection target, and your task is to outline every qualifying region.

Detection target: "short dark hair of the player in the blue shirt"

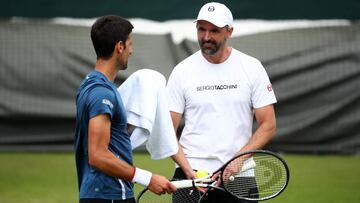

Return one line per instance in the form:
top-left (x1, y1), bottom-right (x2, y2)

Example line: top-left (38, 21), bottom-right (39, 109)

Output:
top-left (91, 15), bottom-right (134, 59)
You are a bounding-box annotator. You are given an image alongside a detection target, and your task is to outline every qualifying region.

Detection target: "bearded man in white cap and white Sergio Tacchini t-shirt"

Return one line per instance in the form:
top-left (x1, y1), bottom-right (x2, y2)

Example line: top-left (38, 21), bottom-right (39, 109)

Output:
top-left (167, 2), bottom-right (276, 202)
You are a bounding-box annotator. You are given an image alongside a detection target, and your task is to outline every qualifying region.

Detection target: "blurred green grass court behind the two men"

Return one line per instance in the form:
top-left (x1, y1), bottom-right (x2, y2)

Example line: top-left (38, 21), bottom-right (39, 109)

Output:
top-left (0, 153), bottom-right (360, 203)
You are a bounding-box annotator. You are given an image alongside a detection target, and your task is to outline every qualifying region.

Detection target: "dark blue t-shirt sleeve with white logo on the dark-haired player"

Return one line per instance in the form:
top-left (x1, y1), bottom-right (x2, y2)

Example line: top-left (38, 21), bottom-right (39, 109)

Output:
top-left (88, 86), bottom-right (116, 118)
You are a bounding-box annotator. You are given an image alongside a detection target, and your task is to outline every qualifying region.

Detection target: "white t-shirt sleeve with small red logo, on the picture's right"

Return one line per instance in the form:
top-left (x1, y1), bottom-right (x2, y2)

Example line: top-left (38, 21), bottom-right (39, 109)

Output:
top-left (252, 62), bottom-right (276, 108)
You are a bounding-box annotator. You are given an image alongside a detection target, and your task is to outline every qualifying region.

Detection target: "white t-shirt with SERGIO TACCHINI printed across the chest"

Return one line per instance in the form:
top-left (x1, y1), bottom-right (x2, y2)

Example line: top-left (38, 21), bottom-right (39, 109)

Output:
top-left (167, 48), bottom-right (276, 172)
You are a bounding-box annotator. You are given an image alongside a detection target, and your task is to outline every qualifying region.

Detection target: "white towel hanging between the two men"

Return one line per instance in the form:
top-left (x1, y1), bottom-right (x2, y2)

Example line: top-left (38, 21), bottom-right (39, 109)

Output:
top-left (118, 69), bottom-right (178, 159)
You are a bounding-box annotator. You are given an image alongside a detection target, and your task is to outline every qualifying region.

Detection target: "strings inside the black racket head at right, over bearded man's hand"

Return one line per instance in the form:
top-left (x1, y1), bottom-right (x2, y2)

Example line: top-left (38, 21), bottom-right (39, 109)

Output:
top-left (223, 154), bottom-right (287, 199)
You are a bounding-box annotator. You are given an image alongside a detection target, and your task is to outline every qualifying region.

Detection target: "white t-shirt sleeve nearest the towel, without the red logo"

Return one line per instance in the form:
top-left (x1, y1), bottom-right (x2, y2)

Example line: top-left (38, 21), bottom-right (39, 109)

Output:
top-left (166, 67), bottom-right (185, 113)
